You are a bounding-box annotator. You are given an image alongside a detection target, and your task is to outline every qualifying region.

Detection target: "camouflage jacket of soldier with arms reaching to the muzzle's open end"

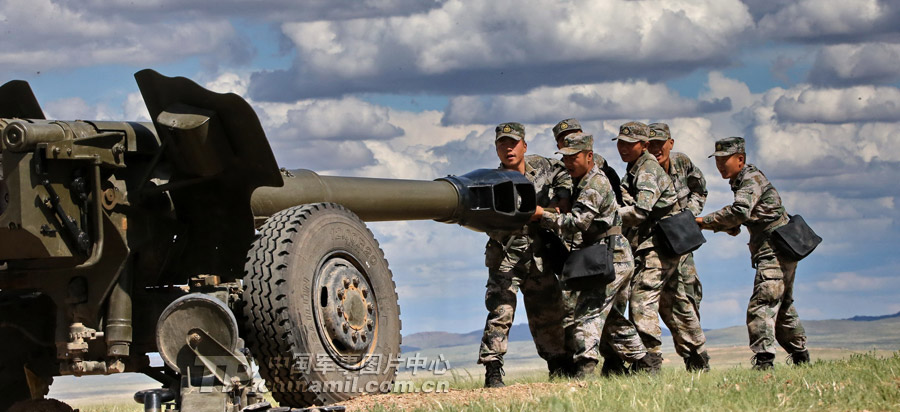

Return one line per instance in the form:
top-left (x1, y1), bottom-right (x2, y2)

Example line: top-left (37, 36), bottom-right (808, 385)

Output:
top-left (540, 165), bottom-right (622, 249)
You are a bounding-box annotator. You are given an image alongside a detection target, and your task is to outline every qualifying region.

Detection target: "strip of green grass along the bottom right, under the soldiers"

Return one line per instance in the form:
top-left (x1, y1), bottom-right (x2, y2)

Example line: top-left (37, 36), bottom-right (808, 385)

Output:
top-left (368, 352), bottom-right (900, 412)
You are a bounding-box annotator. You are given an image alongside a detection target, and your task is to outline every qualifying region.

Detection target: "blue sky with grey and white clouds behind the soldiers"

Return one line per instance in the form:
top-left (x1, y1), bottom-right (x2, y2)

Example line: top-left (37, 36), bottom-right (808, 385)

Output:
top-left (0, 0), bottom-right (900, 334)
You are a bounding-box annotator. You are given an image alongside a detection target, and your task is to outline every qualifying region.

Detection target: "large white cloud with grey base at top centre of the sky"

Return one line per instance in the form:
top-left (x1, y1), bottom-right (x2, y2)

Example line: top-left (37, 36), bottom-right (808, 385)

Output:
top-left (251, 0), bottom-right (752, 100)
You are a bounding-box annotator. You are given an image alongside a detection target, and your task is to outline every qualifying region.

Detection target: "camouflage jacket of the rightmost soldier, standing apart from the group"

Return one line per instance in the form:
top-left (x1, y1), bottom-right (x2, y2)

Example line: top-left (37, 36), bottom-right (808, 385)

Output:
top-left (703, 163), bottom-right (787, 248)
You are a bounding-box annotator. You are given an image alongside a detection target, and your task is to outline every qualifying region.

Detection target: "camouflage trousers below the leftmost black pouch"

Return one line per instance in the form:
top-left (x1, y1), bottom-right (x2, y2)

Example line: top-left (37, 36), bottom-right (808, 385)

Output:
top-left (564, 236), bottom-right (646, 362)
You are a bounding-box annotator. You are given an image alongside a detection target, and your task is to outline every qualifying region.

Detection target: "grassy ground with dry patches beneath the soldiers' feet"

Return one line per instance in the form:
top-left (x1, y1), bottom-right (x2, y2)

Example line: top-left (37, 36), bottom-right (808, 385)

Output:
top-left (72, 348), bottom-right (900, 412)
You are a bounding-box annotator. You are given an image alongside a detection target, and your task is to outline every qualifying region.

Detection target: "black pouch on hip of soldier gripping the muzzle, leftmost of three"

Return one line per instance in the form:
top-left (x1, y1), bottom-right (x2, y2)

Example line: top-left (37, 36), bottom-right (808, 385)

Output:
top-left (559, 241), bottom-right (616, 290)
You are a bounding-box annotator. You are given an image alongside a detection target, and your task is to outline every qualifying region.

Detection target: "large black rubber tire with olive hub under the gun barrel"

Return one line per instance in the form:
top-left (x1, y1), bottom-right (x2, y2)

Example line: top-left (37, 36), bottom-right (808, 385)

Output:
top-left (243, 203), bottom-right (400, 407)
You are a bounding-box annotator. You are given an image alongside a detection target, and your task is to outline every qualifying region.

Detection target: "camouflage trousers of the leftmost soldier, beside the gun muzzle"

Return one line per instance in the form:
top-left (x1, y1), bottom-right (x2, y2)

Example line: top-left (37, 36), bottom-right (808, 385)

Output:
top-left (478, 251), bottom-right (566, 364)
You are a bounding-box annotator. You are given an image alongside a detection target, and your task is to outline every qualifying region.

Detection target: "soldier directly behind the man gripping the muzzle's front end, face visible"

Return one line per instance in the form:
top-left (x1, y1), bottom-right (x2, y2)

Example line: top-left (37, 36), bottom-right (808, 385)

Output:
top-left (613, 122), bottom-right (678, 373)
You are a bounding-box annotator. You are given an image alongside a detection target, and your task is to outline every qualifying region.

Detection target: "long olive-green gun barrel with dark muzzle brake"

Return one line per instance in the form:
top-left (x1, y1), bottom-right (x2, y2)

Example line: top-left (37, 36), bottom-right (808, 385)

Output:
top-left (250, 169), bottom-right (536, 231)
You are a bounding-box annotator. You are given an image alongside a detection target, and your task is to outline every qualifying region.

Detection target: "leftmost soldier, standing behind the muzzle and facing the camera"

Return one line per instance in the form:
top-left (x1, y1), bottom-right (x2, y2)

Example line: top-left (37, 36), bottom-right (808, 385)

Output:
top-left (478, 123), bottom-right (572, 388)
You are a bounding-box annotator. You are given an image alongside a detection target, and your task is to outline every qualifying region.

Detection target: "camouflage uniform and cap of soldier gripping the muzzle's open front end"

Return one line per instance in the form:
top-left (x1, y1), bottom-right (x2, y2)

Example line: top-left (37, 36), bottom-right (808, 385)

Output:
top-left (540, 134), bottom-right (644, 363)
